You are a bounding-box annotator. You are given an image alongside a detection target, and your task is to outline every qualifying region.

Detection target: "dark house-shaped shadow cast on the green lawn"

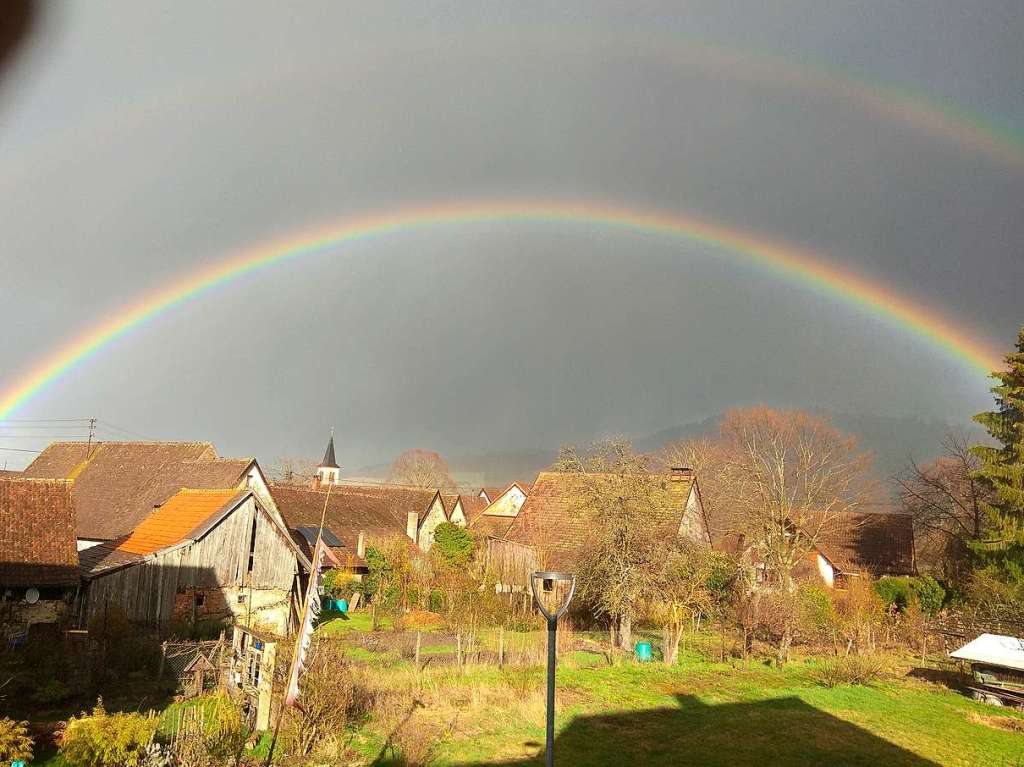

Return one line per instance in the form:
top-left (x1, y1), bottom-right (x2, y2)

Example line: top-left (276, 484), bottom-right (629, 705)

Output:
top-left (452, 695), bottom-right (935, 767)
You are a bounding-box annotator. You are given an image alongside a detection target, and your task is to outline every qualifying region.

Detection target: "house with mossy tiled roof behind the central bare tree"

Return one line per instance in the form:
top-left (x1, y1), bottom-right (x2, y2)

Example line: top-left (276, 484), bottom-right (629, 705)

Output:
top-left (485, 469), bottom-right (711, 587)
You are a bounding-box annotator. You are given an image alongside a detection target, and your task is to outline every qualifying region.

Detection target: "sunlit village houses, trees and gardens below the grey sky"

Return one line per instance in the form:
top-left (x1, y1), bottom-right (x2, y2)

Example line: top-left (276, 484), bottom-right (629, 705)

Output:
top-left (0, 346), bottom-right (1024, 766)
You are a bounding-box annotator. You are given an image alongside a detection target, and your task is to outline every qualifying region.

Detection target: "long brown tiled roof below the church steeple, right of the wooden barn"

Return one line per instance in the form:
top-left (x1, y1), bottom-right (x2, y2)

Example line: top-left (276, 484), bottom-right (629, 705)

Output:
top-left (270, 484), bottom-right (436, 553)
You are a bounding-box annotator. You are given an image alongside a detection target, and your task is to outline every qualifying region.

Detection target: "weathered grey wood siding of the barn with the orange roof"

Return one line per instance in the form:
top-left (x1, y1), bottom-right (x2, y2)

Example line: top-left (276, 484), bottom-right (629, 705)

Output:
top-left (85, 497), bottom-right (298, 623)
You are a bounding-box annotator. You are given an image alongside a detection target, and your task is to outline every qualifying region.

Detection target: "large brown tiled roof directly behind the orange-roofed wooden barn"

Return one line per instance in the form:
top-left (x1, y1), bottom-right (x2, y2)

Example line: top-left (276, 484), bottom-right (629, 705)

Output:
top-left (25, 442), bottom-right (252, 541)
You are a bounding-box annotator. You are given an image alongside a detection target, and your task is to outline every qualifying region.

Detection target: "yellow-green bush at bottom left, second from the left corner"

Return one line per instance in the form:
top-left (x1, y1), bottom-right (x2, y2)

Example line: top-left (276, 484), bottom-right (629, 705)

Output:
top-left (60, 700), bottom-right (157, 767)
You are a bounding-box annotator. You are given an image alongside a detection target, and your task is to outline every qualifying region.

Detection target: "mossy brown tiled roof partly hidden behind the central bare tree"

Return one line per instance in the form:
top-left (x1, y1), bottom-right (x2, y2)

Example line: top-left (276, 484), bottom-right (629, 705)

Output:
top-left (504, 472), bottom-right (693, 568)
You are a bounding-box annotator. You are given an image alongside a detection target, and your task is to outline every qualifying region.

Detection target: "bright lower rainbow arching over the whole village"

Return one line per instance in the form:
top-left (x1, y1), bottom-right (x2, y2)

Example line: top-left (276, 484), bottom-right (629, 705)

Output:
top-left (0, 201), bottom-right (999, 419)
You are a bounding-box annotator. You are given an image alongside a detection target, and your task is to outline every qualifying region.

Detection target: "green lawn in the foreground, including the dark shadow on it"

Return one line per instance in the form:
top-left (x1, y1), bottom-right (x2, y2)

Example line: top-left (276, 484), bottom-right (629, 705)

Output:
top-left (352, 658), bottom-right (1024, 767)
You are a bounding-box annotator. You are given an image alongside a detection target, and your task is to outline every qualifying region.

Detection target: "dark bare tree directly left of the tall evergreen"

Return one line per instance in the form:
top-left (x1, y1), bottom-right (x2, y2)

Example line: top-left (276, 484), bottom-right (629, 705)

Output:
top-left (896, 433), bottom-right (988, 582)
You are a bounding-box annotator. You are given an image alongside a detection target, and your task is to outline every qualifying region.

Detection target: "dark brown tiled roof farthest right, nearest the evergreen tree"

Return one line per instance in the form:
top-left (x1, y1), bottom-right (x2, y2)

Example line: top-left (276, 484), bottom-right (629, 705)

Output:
top-left (817, 512), bottom-right (914, 577)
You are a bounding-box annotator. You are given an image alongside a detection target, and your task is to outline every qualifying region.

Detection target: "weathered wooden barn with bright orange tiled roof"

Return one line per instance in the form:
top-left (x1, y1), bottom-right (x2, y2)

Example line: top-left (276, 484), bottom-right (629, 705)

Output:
top-left (79, 487), bottom-right (309, 636)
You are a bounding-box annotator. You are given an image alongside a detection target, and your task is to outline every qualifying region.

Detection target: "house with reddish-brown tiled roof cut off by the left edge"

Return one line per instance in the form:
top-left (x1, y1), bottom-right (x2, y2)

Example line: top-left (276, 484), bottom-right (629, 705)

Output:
top-left (0, 478), bottom-right (79, 635)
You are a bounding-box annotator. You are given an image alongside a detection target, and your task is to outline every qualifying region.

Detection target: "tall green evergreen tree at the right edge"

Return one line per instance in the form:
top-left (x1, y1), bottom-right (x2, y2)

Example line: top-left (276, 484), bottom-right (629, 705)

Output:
top-left (972, 328), bottom-right (1024, 595)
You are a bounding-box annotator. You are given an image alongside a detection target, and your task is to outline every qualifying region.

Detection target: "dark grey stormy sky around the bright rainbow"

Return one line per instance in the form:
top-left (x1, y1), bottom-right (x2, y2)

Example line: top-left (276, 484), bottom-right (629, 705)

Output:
top-left (0, 0), bottom-right (1024, 468)
